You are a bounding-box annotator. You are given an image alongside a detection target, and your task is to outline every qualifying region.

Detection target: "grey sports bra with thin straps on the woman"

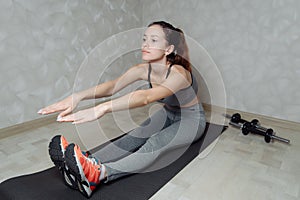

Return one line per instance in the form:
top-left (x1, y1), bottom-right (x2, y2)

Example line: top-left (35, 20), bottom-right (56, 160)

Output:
top-left (148, 63), bottom-right (198, 107)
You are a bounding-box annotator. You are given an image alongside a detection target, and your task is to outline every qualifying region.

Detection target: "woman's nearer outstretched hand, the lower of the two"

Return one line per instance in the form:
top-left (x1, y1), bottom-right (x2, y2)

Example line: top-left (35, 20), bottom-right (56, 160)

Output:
top-left (58, 104), bottom-right (107, 124)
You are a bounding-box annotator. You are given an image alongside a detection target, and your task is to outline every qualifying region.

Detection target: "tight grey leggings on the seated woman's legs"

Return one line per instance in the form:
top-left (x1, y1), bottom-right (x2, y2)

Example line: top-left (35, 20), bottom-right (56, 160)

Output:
top-left (93, 104), bottom-right (206, 181)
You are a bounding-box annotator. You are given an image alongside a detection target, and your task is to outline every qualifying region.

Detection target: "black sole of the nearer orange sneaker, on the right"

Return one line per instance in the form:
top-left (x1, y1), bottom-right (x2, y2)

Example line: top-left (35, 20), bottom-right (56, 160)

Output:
top-left (65, 144), bottom-right (92, 198)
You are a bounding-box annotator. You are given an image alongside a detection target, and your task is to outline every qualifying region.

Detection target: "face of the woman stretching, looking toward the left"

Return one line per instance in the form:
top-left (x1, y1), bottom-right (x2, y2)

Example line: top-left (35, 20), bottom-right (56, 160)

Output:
top-left (142, 25), bottom-right (169, 62)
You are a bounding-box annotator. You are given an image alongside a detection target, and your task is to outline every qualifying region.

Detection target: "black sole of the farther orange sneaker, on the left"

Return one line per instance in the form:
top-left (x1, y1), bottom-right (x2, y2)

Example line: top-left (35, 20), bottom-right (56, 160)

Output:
top-left (49, 135), bottom-right (78, 190)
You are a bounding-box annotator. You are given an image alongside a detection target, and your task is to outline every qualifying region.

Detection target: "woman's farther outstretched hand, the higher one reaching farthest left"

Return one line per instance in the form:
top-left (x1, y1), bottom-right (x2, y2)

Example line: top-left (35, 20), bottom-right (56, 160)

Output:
top-left (38, 94), bottom-right (81, 120)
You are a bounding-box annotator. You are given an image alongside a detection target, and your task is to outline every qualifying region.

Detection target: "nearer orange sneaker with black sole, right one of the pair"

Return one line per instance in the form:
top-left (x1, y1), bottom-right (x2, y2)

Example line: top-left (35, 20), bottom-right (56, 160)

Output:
top-left (66, 144), bottom-right (102, 197)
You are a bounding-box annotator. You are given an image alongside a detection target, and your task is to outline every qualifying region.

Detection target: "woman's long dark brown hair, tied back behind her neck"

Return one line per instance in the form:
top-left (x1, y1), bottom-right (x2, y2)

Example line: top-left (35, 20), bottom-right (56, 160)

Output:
top-left (148, 21), bottom-right (192, 72)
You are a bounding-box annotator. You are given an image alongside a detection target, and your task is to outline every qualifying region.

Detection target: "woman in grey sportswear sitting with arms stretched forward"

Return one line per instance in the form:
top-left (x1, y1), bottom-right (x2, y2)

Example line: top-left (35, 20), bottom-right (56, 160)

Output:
top-left (39, 21), bottom-right (205, 197)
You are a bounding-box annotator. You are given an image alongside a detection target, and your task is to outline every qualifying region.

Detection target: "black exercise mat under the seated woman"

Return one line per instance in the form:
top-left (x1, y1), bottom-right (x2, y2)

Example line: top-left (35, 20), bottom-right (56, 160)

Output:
top-left (0, 123), bottom-right (227, 200)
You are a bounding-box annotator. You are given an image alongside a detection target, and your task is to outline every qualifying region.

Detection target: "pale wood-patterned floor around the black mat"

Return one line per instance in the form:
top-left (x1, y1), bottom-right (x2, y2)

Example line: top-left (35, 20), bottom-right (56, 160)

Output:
top-left (0, 105), bottom-right (300, 200)
